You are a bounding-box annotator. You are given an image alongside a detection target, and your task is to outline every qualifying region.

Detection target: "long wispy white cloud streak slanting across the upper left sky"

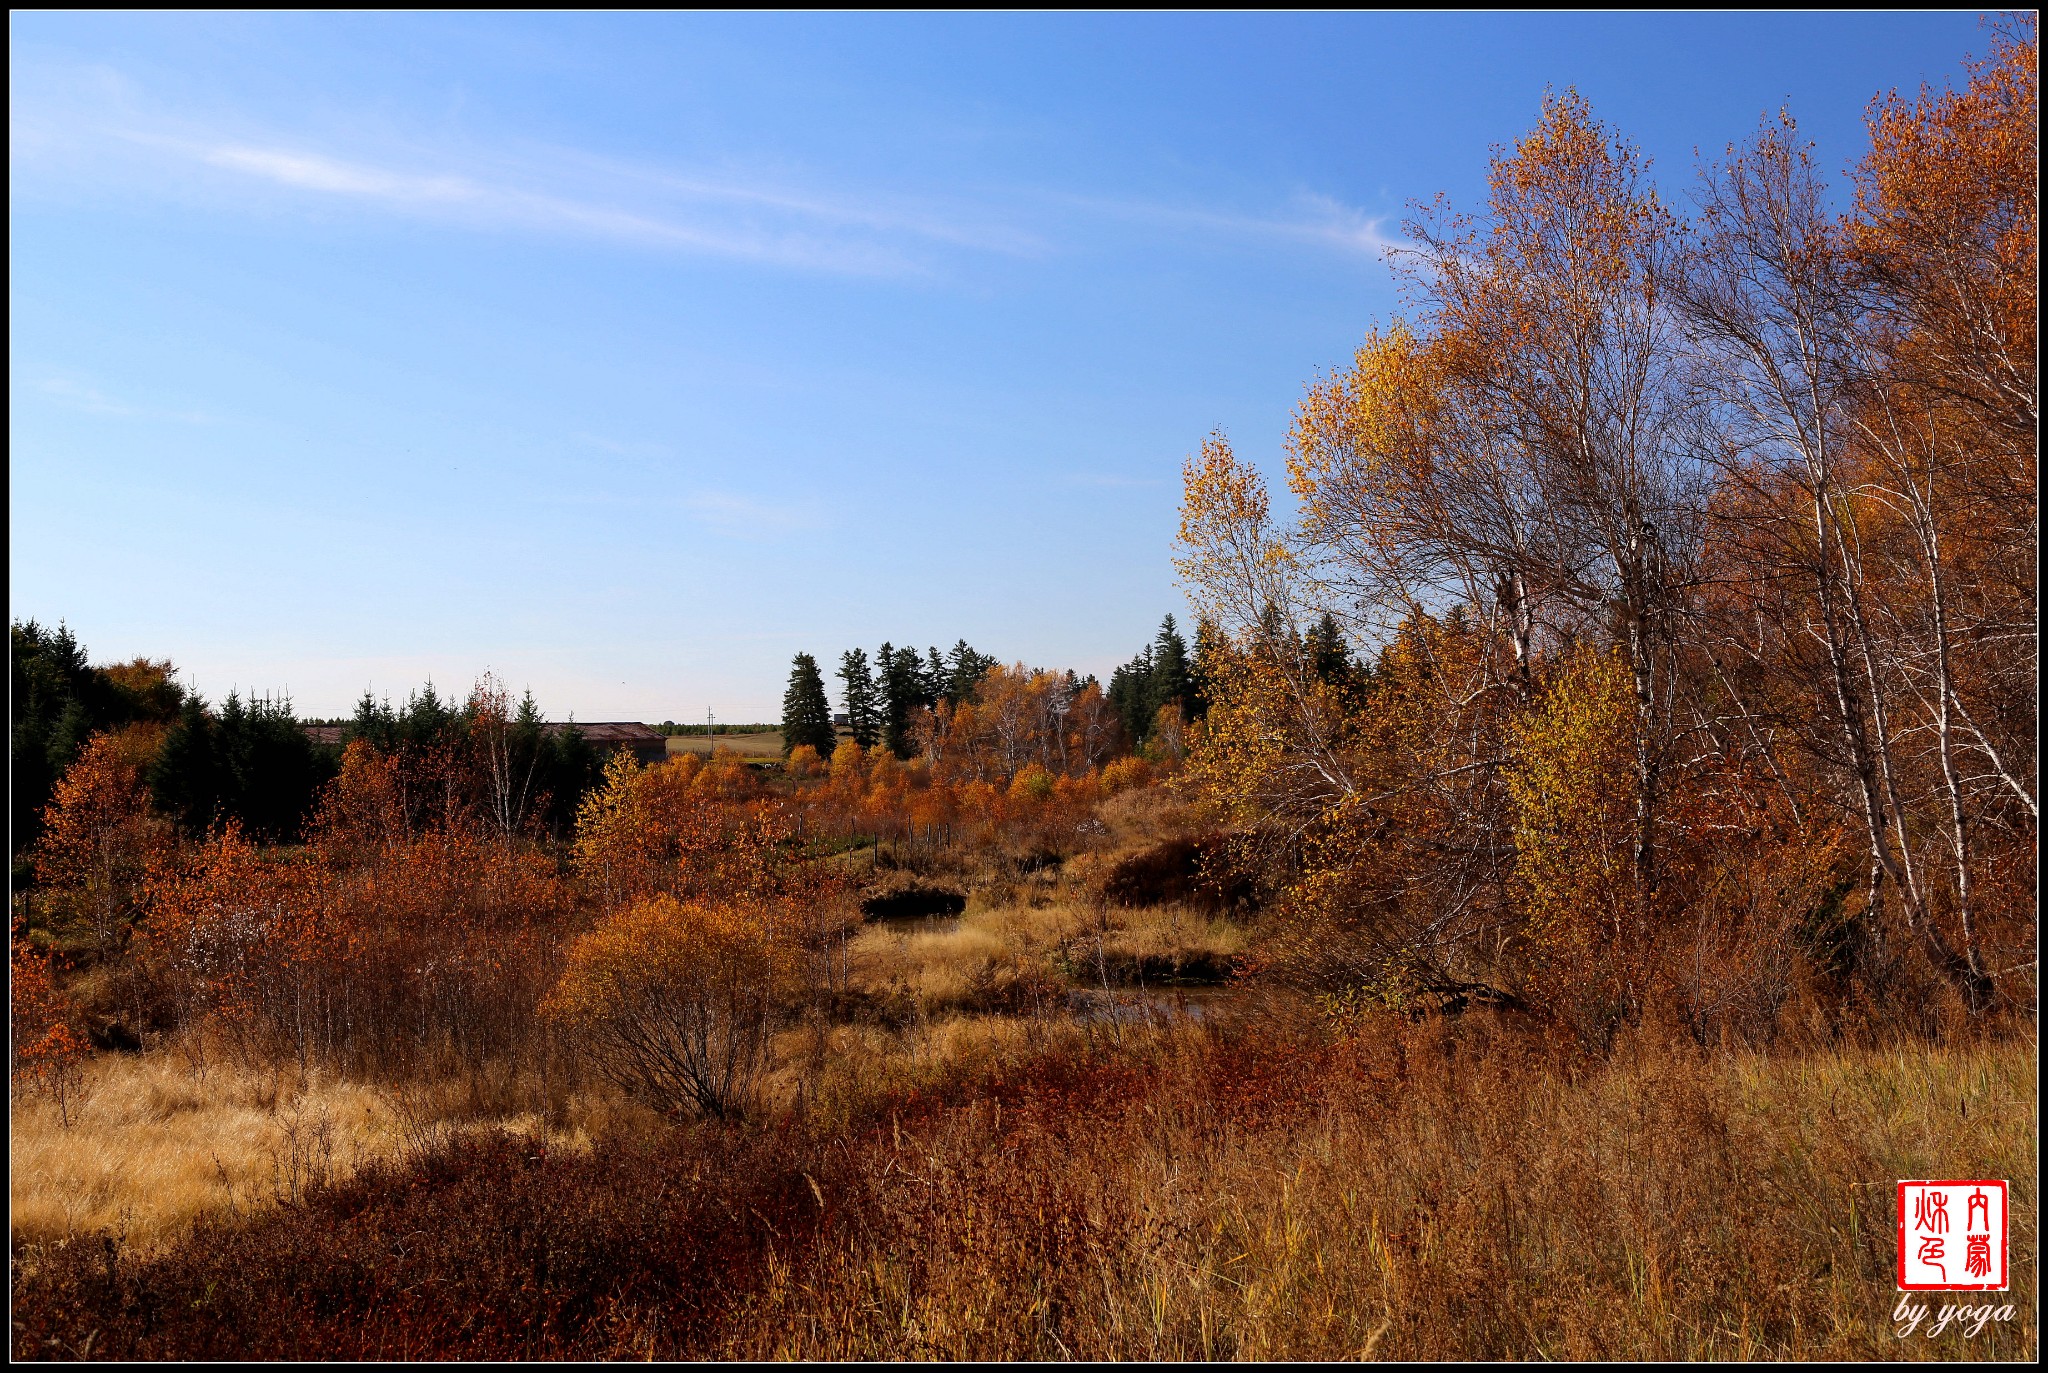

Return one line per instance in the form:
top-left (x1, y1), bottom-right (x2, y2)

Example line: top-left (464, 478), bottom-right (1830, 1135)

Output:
top-left (10, 66), bottom-right (1401, 277)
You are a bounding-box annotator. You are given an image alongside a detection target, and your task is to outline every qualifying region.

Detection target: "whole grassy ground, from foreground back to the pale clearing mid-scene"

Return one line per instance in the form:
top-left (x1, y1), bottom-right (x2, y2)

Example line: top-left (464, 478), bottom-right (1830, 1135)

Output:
top-left (8, 807), bottom-right (2038, 1361)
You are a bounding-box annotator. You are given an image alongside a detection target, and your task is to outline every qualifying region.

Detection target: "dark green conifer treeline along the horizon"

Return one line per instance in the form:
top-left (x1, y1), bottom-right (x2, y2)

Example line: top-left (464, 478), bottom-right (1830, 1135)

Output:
top-left (10, 615), bottom-right (1277, 860)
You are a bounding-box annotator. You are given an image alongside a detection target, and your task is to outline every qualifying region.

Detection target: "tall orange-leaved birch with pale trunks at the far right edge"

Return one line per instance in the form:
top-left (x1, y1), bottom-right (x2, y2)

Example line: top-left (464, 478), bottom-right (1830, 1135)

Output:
top-left (1845, 14), bottom-right (2040, 1006)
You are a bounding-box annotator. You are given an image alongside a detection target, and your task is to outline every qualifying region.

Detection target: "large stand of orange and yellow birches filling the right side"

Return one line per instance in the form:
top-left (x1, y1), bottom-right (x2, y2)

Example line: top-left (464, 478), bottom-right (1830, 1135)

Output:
top-left (1179, 51), bottom-right (2038, 1025)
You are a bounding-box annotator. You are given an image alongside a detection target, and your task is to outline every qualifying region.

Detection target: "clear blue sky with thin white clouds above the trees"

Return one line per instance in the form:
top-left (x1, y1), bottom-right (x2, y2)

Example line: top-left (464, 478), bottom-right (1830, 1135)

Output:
top-left (8, 12), bottom-right (1987, 719)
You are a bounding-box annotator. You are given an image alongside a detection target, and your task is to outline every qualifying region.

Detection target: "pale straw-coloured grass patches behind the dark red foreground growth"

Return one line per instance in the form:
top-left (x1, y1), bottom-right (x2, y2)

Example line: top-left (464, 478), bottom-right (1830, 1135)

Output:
top-left (8, 904), bottom-right (1243, 1248)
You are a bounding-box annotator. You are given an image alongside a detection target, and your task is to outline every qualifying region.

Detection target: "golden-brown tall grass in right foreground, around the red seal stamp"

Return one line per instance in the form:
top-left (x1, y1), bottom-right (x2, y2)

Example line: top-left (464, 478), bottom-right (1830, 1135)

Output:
top-left (729, 1031), bottom-right (2038, 1359)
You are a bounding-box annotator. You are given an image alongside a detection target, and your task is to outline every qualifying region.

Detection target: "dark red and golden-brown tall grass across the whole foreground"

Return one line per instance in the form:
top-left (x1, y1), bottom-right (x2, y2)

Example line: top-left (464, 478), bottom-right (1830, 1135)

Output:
top-left (14, 1016), bottom-right (2038, 1361)
